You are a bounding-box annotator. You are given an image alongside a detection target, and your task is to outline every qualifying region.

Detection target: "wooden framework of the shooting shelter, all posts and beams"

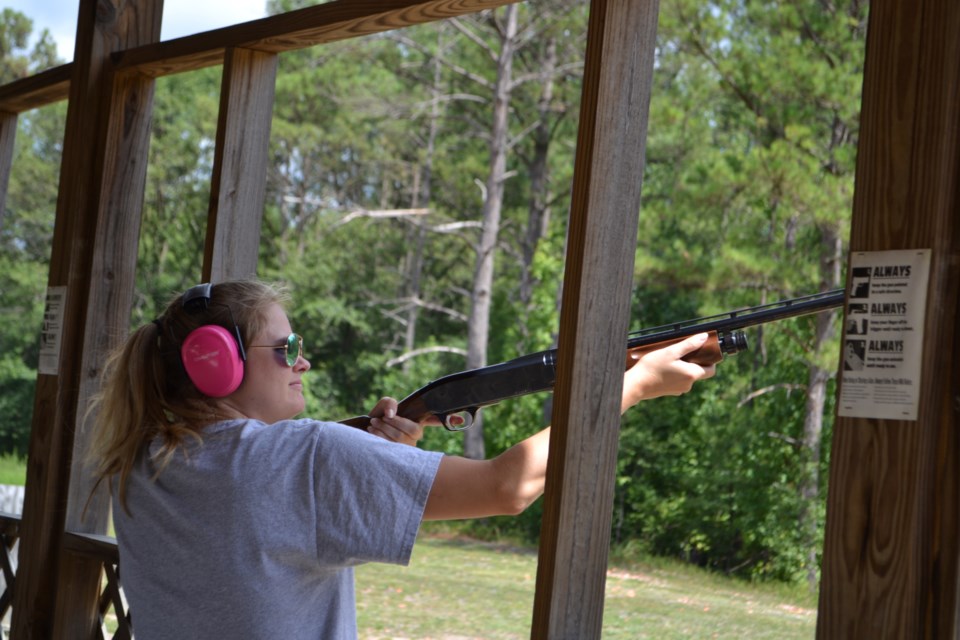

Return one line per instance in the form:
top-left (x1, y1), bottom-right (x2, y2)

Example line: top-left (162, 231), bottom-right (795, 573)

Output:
top-left (0, 0), bottom-right (960, 640)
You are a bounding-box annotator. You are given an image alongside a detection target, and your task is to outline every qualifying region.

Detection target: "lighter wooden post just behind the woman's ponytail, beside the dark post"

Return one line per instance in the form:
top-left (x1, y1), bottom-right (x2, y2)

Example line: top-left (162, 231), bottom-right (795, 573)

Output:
top-left (54, 67), bottom-right (155, 638)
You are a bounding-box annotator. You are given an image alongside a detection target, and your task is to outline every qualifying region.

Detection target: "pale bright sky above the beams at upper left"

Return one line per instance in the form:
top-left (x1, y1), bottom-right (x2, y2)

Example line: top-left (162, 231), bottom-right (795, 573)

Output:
top-left (0, 0), bottom-right (267, 62)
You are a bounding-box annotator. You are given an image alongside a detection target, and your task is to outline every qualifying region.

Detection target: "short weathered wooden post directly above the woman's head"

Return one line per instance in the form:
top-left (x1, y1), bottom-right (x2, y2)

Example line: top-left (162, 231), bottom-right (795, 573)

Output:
top-left (203, 49), bottom-right (279, 282)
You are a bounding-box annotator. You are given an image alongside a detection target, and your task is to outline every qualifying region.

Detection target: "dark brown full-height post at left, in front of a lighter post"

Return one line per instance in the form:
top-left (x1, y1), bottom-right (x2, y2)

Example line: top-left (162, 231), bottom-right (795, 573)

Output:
top-left (12, 0), bottom-right (163, 638)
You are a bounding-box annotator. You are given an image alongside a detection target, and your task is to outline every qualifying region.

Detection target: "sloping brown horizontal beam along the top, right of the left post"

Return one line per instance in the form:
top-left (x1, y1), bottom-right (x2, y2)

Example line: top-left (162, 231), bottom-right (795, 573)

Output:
top-left (115, 0), bottom-right (516, 76)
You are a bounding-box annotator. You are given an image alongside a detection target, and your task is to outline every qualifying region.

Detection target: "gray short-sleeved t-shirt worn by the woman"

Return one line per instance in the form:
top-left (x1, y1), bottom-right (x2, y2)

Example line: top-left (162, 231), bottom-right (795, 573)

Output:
top-left (114, 420), bottom-right (442, 640)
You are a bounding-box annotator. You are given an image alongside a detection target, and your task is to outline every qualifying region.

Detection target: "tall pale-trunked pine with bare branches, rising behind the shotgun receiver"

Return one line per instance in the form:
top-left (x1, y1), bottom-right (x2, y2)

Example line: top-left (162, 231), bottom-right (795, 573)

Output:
top-left (396, 2), bottom-right (584, 458)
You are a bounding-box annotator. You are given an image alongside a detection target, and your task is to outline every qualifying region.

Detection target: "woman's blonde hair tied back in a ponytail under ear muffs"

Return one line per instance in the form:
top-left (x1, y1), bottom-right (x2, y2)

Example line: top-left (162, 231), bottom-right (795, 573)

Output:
top-left (87, 280), bottom-right (289, 513)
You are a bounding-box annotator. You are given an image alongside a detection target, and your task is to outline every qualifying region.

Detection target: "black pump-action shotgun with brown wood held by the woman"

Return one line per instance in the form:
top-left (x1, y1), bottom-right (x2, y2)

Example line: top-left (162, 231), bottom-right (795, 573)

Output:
top-left (341, 289), bottom-right (844, 431)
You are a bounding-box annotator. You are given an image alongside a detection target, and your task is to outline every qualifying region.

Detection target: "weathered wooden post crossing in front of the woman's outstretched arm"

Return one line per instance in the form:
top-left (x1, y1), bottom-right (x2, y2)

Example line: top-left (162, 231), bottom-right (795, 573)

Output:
top-left (531, 0), bottom-right (659, 640)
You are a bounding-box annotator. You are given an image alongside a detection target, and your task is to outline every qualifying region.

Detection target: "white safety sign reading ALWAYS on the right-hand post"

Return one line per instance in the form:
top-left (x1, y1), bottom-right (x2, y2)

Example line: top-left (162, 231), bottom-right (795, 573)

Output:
top-left (837, 249), bottom-right (930, 420)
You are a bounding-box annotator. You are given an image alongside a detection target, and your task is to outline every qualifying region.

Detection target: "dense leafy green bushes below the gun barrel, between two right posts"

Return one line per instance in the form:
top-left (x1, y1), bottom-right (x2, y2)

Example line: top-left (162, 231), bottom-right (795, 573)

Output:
top-left (615, 304), bottom-right (829, 581)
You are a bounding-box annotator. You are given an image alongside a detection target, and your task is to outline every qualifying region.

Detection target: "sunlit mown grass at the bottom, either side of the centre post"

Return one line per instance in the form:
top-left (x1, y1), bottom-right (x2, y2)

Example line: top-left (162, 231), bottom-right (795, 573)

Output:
top-left (357, 536), bottom-right (816, 640)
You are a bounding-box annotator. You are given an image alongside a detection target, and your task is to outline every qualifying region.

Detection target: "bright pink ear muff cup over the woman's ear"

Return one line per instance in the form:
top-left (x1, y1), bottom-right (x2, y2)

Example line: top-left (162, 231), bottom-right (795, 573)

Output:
top-left (180, 324), bottom-right (243, 398)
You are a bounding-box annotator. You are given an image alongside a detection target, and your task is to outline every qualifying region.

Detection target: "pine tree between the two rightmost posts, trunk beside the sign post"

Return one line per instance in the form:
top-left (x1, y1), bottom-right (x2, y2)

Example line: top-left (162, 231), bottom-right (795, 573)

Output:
top-left (624, 0), bottom-right (866, 586)
